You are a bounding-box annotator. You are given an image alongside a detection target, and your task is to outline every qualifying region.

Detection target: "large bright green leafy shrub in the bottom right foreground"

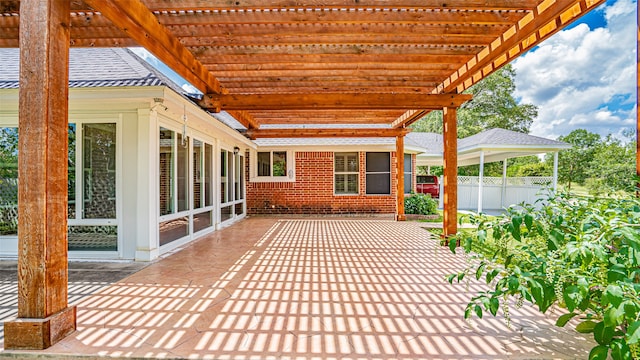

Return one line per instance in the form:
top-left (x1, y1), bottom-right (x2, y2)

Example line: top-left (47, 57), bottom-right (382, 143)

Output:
top-left (448, 195), bottom-right (640, 359)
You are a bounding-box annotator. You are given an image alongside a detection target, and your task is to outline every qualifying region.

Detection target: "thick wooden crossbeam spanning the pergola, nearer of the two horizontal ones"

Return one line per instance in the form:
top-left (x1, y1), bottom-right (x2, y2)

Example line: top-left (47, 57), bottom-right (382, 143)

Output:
top-left (199, 93), bottom-right (472, 112)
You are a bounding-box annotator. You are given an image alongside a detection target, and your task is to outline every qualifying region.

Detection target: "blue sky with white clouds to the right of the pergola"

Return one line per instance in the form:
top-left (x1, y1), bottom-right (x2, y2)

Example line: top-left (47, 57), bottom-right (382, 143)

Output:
top-left (513, 0), bottom-right (637, 138)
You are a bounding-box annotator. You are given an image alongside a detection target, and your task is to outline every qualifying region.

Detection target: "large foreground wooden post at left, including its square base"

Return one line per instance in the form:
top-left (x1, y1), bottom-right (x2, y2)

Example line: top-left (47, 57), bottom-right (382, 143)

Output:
top-left (4, 0), bottom-right (76, 349)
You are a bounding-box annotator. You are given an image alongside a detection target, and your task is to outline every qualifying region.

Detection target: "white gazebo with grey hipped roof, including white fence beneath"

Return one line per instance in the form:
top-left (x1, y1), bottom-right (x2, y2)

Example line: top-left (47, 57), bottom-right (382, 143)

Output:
top-left (407, 128), bottom-right (571, 212)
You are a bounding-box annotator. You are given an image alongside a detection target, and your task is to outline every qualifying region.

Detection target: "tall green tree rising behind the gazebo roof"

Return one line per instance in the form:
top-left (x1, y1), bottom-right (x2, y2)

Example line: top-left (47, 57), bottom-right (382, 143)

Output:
top-left (411, 65), bottom-right (538, 138)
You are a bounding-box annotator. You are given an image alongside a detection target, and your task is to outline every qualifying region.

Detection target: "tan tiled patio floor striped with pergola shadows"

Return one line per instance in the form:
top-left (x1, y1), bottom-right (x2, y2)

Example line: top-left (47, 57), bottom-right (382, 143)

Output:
top-left (0, 218), bottom-right (591, 359)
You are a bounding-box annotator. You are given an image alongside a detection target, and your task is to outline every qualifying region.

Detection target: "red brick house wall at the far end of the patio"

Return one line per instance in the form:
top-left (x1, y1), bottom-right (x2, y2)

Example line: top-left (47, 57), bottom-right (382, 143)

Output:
top-left (247, 152), bottom-right (396, 215)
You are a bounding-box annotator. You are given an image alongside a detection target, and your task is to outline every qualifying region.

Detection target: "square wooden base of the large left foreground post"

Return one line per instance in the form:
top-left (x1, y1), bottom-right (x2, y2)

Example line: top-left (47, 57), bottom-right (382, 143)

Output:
top-left (4, 305), bottom-right (76, 350)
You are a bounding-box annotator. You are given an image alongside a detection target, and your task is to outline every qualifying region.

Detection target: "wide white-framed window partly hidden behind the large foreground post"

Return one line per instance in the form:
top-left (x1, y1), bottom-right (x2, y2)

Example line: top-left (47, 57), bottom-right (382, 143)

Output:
top-left (0, 122), bottom-right (119, 251)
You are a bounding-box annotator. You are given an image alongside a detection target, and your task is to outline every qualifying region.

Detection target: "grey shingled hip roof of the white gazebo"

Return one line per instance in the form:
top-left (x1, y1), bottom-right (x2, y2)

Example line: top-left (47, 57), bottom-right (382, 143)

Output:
top-left (407, 128), bottom-right (571, 166)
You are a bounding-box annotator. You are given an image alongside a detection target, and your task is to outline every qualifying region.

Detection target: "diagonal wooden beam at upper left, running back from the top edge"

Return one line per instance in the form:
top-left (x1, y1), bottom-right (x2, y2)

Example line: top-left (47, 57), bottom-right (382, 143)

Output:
top-left (85, 0), bottom-right (224, 94)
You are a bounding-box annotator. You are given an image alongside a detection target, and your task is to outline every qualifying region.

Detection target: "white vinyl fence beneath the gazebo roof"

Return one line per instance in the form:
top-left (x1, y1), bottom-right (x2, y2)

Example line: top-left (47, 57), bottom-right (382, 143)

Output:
top-left (440, 176), bottom-right (553, 211)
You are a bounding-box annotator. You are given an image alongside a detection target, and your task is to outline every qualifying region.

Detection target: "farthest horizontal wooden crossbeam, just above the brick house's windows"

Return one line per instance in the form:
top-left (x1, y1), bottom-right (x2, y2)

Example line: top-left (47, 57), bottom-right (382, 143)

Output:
top-left (246, 128), bottom-right (409, 140)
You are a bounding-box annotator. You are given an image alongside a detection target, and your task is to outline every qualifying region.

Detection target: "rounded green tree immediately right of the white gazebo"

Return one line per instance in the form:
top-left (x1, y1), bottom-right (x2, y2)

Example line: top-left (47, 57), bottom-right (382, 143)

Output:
top-left (547, 129), bottom-right (601, 191)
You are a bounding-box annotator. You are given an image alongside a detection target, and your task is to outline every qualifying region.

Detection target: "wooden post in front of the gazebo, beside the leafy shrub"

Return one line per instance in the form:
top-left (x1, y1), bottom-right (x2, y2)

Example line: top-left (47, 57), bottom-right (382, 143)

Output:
top-left (442, 108), bottom-right (458, 239)
